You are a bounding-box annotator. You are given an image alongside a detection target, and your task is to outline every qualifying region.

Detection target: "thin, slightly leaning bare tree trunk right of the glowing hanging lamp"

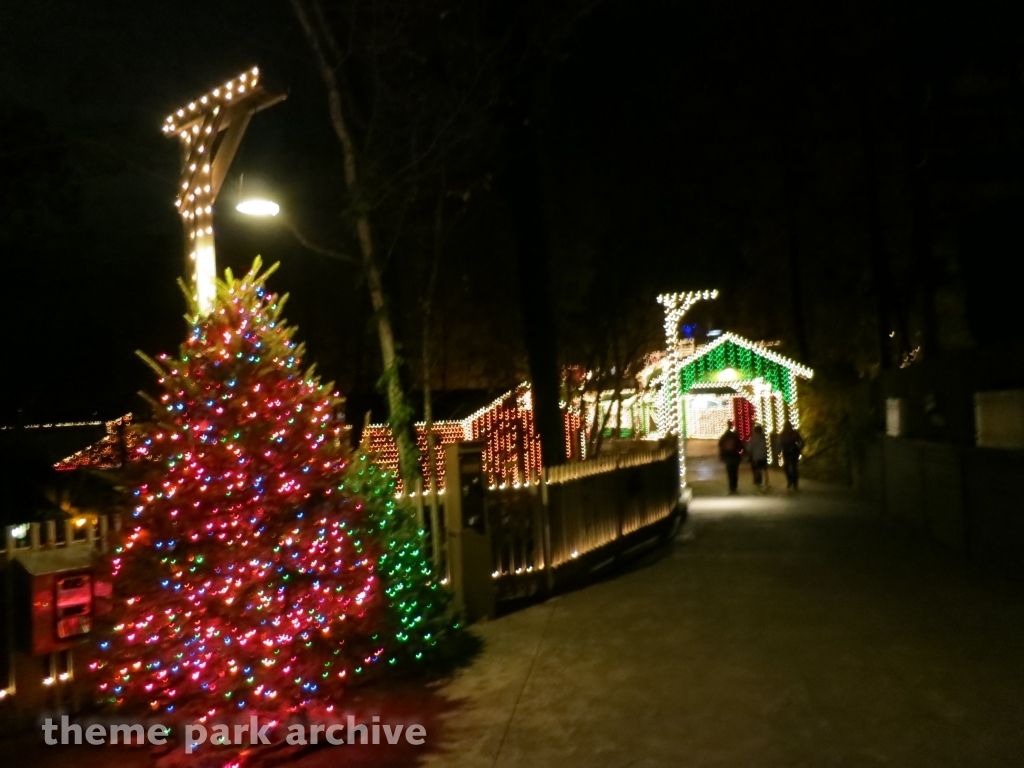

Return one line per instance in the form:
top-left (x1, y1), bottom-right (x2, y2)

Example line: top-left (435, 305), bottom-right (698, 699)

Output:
top-left (292, 0), bottom-right (420, 492)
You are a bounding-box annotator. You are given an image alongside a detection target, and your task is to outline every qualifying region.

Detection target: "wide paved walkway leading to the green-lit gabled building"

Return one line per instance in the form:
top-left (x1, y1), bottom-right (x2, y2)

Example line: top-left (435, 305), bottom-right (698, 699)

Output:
top-left (421, 450), bottom-right (1024, 768)
